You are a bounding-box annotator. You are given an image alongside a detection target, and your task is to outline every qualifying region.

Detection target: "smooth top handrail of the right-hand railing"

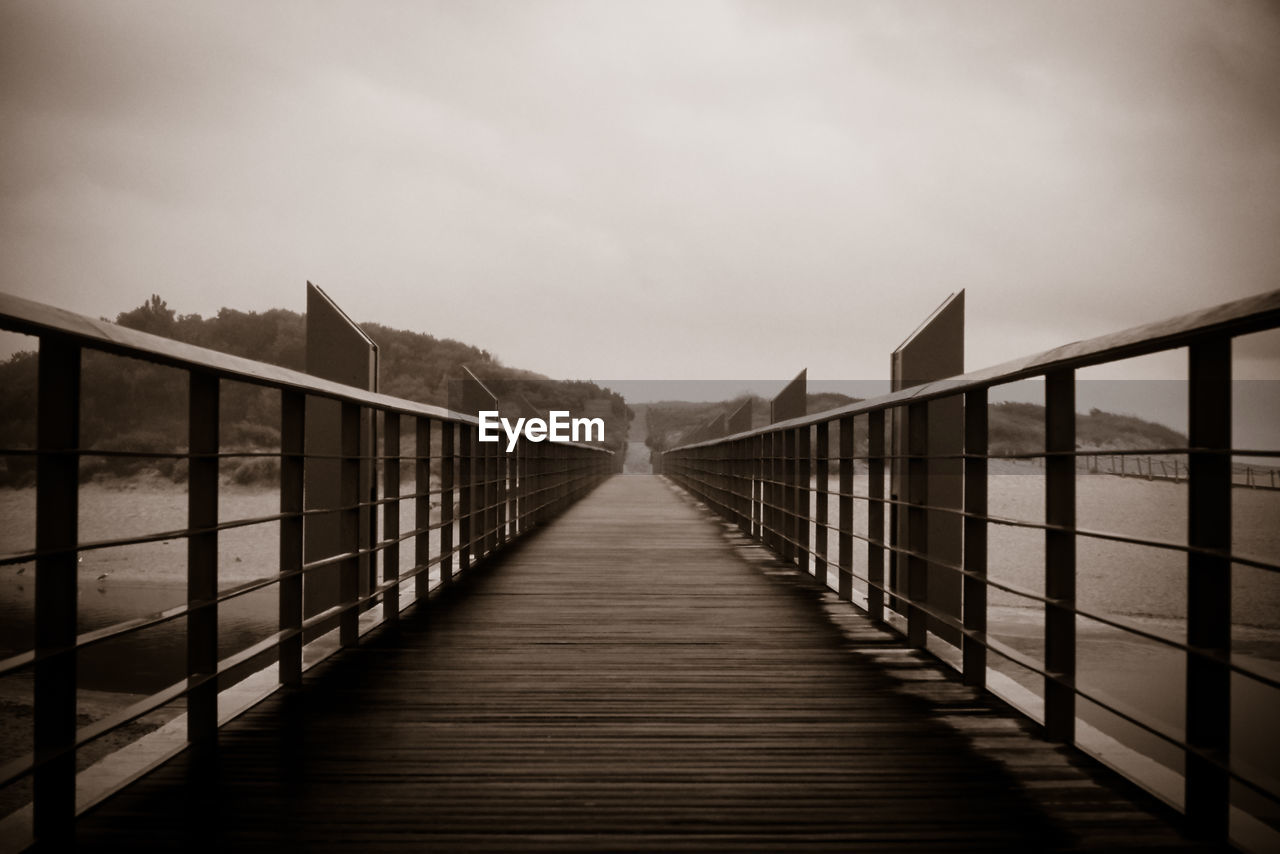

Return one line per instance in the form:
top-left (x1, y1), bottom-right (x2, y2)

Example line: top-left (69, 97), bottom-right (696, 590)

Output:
top-left (663, 289), bottom-right (1280, 453)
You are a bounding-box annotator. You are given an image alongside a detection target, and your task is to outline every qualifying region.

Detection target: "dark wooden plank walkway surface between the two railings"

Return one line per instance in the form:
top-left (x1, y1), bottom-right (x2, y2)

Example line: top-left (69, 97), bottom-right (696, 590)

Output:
top-left (77, 475), bottom-right (1213, 851)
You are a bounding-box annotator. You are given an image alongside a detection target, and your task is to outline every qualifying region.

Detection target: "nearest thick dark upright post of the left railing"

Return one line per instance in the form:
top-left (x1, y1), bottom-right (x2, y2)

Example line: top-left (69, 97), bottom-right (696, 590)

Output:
top-left (33, 335), bottom-right (81, 845)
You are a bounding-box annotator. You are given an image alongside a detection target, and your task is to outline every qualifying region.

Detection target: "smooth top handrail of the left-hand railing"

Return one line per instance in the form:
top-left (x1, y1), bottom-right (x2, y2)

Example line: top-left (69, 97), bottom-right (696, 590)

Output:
top-left (0, 291), bottom-right (613, 455)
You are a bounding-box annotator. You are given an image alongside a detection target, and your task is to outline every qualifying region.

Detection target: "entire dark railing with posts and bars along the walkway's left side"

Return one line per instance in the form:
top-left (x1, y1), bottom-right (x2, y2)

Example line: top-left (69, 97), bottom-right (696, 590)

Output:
top-left (0, 294), bottom-right (614, 842)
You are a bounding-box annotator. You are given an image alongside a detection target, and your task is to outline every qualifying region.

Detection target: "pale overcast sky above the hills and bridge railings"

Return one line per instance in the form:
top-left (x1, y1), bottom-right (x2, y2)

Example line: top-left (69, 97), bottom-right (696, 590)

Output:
top-left (0, 0), bottom-right (1280, 391)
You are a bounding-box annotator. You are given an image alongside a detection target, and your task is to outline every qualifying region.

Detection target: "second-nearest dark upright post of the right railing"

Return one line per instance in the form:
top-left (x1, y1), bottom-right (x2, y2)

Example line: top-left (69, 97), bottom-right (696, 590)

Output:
top-left (1044, 369), bottom-right (1075, 744)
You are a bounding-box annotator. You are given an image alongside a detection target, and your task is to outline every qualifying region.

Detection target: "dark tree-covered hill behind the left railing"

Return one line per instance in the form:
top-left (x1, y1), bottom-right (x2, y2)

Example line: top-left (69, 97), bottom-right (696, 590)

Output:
top-left (0, 296), bottom-right (631, 485)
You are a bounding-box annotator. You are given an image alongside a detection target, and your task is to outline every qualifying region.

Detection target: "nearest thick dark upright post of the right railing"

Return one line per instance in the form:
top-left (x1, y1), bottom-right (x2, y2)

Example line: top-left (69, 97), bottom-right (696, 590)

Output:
top-left (1185, 335), bottom-right (1231, 839)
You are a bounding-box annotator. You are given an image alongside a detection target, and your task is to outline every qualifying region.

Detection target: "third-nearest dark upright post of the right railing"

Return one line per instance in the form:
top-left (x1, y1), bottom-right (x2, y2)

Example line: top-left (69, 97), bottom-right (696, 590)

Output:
top-left (960, 388), bottom-right (987, 688)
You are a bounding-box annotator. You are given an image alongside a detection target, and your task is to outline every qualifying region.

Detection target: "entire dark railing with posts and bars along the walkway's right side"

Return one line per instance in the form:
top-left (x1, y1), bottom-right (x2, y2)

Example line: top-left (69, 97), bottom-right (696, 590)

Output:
top-left (659, 285), bottom-right (1280, 839)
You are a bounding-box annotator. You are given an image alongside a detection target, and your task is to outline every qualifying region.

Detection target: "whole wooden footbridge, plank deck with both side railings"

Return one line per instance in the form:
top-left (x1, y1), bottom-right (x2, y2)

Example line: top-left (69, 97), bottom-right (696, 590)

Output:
top-left (0, 293), bottom-right (1280, 851)
